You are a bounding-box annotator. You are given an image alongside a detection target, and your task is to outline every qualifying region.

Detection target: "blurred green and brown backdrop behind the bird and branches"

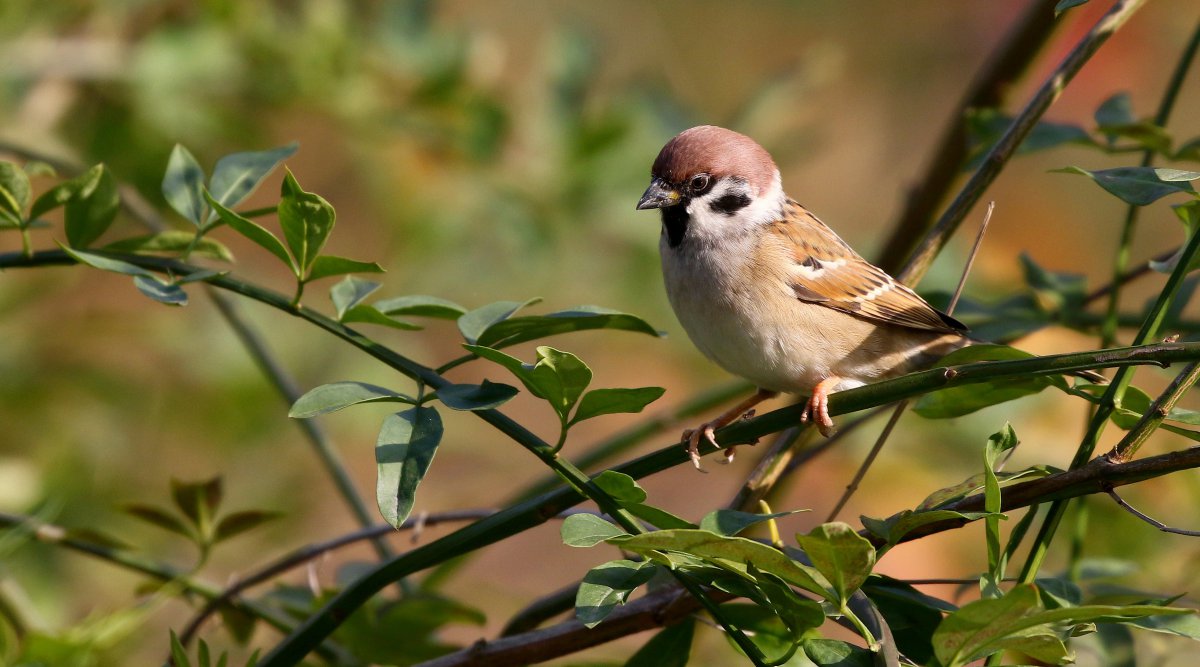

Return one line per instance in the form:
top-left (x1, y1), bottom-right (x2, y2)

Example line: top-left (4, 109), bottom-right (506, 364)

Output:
top-left (0, 0), bottom-right (1200, 665)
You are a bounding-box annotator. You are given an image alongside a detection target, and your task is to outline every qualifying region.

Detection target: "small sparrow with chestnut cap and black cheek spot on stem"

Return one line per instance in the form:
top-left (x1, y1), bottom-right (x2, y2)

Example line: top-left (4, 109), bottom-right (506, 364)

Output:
top-left (637, 125), bottom-right (972, 468)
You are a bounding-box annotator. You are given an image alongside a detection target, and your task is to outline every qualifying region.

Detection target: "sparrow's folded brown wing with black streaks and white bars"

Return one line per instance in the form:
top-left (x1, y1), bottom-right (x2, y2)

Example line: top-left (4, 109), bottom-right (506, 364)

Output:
top-left (772, 202), bottom-right (967, 332)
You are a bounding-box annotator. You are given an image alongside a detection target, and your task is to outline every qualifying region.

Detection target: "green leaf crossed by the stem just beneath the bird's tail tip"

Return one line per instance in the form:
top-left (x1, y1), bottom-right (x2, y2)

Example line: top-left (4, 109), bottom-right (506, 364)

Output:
top-left (913, 344), bottom-right (1067, 419)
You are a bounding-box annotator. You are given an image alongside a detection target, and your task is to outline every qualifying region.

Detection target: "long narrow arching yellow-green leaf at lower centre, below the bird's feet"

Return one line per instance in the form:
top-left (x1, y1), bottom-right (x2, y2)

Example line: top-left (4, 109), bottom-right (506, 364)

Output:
top-left (610, 529), bottom-right (829, 597)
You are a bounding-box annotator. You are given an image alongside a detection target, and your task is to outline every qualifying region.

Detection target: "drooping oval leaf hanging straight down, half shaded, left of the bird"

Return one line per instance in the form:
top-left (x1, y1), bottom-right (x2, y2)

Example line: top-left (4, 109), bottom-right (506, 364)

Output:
top-left (376, 407), bottom-right (442, 528)
